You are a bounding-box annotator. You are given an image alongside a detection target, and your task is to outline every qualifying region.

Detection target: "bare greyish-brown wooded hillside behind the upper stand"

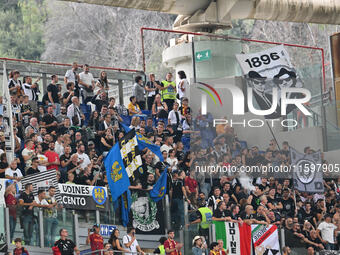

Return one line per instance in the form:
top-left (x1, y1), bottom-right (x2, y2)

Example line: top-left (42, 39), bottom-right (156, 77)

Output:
top-left (42, 1), bottom-right (176, 73)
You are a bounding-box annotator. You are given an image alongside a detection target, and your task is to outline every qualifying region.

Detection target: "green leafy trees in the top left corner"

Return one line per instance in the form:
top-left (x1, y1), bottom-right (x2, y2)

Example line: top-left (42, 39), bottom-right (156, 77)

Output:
top-left (0, 0), bottom-right (47, 59)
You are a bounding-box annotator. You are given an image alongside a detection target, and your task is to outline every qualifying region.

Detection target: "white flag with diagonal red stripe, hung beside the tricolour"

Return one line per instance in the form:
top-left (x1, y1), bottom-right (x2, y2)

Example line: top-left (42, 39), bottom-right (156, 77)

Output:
top-left (251, 225), bottom-right (280, 255)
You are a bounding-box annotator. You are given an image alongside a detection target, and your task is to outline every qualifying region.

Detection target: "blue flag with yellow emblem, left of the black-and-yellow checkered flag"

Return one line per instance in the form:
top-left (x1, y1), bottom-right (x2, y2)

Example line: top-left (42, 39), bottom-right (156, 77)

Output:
top-left (104, 143), bottom-right (130, 201)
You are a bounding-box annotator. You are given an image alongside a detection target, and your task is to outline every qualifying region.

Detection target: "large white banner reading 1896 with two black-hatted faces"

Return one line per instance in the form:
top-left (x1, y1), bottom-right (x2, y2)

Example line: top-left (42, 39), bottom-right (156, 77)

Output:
top-left (236, 45), bottom-right (303, 119)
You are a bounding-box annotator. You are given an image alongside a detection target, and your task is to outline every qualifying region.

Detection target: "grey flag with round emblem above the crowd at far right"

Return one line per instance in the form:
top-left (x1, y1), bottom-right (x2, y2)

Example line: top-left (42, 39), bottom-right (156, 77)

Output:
top-left (290, 148), bottom-right (324, 193)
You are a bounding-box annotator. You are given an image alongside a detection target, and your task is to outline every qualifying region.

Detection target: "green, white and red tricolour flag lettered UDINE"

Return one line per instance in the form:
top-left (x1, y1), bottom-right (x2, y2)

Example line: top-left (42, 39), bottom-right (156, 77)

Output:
top-left (214, 221), bottom-right (251, 255)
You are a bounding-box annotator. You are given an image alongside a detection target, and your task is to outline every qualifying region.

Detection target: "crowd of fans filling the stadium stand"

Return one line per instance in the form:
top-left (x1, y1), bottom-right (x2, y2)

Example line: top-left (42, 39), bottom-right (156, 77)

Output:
top-left (0, 60), bottom-right (340, 255)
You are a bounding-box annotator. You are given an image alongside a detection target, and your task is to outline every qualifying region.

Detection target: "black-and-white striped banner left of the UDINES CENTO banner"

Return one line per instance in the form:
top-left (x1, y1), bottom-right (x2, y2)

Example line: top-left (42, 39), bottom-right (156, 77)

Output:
top-left (21, 169), bottom-right (61, 203)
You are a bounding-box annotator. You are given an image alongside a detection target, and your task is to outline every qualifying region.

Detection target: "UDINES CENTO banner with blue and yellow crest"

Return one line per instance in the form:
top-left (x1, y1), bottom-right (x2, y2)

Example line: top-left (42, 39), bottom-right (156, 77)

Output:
top-left (59, 184), bottom-right (108, 211)
